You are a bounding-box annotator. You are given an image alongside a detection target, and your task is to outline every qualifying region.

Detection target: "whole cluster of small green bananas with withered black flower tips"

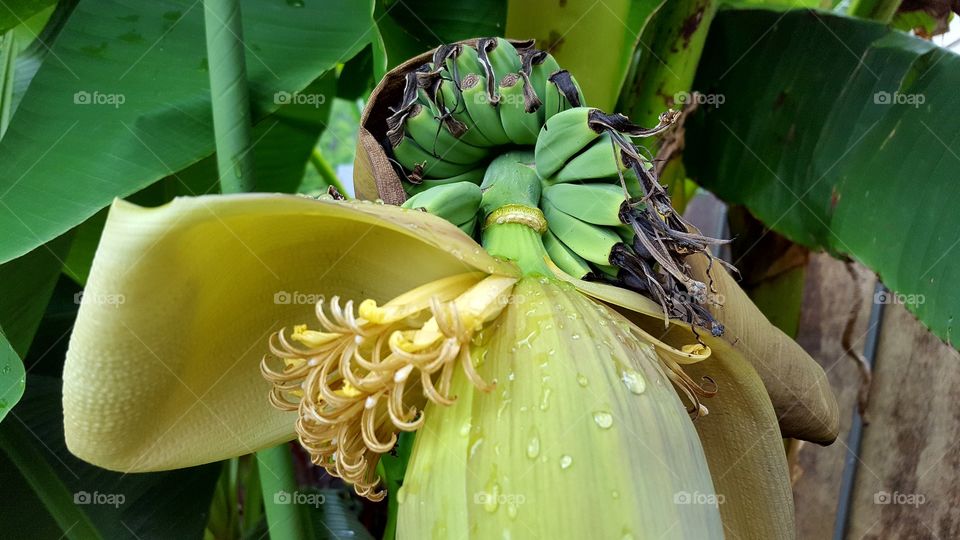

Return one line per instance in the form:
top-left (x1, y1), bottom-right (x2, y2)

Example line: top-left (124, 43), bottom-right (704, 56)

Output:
top-left (384, 38), bottom-right (723, 336)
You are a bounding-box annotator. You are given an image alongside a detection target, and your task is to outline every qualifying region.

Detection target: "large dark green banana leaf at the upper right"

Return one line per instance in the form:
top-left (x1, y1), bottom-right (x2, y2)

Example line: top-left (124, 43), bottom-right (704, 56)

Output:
top-left (685, 10), bottom-right (960, 342)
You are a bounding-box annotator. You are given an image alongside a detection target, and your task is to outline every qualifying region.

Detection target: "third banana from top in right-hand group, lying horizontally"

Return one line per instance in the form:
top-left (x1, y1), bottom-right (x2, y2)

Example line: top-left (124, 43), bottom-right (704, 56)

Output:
top-left (543, 183), bottom-right (626, 227)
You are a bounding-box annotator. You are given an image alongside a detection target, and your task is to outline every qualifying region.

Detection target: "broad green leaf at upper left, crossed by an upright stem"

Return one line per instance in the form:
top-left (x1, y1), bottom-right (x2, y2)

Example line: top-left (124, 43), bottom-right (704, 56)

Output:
top-left (0, 0), bottom-right (373, 262)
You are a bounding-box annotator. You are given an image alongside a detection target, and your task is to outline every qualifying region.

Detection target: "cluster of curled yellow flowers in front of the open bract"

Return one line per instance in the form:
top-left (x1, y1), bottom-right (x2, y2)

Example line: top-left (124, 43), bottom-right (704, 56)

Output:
top-left (260, 273), bottom-right (517, 500)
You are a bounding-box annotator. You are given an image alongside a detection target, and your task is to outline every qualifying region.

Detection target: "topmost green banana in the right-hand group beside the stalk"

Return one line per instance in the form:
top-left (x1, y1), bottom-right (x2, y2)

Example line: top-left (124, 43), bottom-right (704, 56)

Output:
top-left (534, 107), bottom-right (600, 180)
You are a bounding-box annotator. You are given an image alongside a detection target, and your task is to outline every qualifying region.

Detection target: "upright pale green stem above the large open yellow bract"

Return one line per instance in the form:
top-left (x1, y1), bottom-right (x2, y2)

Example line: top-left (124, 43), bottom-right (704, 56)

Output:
top-left (203, 0), bottom-right (254, 193)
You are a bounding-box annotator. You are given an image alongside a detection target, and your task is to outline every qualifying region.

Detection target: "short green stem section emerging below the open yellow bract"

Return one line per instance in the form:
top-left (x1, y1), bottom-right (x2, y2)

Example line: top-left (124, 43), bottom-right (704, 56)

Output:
top-left (257, 444), bottom-right (313, 540)
